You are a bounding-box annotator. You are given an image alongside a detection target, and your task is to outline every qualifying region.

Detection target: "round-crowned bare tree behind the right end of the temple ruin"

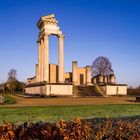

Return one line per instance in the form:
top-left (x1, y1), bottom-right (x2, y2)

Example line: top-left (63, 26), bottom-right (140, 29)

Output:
top-left (92, 56), bottom-right (114, 77)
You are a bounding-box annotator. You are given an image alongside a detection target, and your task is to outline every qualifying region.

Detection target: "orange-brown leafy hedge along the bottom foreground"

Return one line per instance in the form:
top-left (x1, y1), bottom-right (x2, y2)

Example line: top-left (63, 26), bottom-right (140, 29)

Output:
top-left (0, 119), bottom-right (140, 140)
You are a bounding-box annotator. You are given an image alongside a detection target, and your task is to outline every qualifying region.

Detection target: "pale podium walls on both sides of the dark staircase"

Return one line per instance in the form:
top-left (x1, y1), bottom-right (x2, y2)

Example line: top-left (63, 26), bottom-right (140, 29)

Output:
top-left (25, 84), bottom-right (127, 96)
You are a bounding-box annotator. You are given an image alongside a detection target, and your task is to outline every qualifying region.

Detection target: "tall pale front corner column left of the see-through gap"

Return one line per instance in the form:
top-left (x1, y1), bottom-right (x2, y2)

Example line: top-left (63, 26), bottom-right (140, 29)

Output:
top-left (43, 35), bottom-right (49, 82)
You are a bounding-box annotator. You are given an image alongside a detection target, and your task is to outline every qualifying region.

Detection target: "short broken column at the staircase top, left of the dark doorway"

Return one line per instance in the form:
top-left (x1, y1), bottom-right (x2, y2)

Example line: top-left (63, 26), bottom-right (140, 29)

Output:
top-left (72, 61), bottom-right (78, 85)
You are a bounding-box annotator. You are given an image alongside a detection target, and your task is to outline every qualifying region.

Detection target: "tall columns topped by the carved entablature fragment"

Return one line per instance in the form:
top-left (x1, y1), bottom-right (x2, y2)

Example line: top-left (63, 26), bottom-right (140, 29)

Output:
top-left (36, 15), bottom-right (64, 83)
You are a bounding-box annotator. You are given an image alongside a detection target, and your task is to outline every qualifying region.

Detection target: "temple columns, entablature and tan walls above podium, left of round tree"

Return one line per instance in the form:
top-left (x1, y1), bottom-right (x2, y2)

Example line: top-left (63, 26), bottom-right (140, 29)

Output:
top-left (28, 15), bottom-right (91, 85)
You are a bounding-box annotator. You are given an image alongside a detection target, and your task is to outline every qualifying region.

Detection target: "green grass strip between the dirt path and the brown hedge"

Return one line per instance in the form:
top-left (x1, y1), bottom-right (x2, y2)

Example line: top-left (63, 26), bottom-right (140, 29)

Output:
top-left (0, 104), bottom-right (140, 123)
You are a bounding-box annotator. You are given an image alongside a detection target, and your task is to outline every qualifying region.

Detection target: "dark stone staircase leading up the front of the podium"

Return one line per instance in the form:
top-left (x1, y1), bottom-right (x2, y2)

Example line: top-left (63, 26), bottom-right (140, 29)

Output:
top-left (73, 85), bottom-right (104, 97)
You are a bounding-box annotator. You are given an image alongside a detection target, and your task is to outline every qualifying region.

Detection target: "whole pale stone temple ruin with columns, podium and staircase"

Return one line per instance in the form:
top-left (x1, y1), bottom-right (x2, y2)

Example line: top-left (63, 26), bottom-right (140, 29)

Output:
top-left (25, 14), bottom-right (127, 97)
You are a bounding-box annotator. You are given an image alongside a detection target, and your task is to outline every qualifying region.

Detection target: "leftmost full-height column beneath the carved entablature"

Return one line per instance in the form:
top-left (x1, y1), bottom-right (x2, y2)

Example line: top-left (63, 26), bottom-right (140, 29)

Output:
top-left (38, 42), bottom-right (41, 82)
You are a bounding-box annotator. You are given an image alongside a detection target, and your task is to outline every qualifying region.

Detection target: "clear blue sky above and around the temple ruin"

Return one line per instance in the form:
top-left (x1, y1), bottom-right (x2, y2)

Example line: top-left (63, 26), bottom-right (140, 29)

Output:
top-left (0, 0), bottom-right (140, 86)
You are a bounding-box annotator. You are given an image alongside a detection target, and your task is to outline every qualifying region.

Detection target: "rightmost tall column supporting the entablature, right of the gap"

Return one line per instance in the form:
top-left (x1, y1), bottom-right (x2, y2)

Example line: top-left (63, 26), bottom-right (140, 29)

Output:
top-left (58, 34), bottom-right (64, 83)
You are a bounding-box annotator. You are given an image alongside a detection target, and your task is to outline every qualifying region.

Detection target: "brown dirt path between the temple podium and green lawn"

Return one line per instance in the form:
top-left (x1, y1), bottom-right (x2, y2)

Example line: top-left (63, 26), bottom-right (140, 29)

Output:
top-left (1, 95), bottom-right (138, 106)
